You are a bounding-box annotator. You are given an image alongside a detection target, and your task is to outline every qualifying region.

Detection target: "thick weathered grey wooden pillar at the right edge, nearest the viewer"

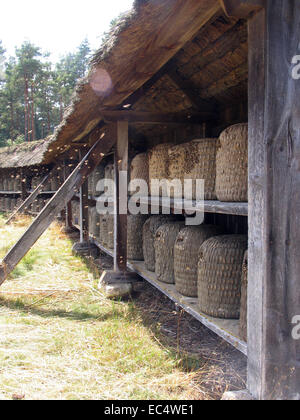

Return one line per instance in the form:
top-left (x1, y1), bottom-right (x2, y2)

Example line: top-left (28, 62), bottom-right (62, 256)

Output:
top-left (248, 0), bottom-right (300, 399)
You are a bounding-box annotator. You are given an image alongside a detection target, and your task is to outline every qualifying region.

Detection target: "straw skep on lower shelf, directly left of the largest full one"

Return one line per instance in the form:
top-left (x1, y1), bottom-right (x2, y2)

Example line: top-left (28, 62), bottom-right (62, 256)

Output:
top-left (174, 225), bottom-right (223, 297)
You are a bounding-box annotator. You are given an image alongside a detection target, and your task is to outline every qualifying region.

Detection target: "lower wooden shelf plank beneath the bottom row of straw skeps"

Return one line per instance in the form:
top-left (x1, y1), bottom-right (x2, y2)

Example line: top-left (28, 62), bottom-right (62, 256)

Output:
top-left (88, 235), bottom-right (247, 356)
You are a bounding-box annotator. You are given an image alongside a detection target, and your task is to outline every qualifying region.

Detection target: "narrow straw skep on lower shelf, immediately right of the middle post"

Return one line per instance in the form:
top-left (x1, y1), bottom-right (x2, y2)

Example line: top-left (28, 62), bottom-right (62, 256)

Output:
top-left (127, 214), bottom-right (147, 261)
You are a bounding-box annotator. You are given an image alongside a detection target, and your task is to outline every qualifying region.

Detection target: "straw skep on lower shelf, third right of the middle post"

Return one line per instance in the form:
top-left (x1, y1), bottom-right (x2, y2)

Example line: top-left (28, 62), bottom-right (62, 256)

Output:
top-left (154, 222), bottom-right (185, 284)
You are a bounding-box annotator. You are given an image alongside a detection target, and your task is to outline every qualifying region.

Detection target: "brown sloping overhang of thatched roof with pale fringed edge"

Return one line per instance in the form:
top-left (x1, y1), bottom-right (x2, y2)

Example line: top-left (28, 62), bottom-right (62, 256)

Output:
top-left (32, 0), bottom-right (221, 163)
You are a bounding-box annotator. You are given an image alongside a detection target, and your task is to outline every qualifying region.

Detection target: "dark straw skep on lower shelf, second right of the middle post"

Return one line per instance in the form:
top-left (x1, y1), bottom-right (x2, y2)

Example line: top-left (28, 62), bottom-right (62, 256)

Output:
top-left (143, 215), bottom-right (174, 272)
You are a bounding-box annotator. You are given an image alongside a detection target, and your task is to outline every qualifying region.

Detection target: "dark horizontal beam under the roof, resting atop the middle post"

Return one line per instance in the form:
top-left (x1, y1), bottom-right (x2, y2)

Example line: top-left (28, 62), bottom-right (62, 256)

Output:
top-left (101, 111), bottom-right (216, 125)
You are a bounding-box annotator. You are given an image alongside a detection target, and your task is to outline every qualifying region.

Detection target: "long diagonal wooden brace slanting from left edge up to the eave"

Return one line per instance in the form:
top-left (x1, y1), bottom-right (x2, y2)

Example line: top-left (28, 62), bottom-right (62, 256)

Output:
top-left (0, 124), bottom-right (116, 285)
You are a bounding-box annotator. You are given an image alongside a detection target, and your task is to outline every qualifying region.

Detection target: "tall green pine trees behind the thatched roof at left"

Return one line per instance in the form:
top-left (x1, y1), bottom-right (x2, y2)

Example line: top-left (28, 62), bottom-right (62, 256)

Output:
top-left (0, 39), bottom-right (91, 147)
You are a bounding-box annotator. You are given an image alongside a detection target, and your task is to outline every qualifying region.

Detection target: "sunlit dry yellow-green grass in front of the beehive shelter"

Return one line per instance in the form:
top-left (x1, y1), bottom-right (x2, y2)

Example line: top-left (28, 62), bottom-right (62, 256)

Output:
top-left (0, 217), bottom-right (213, 400)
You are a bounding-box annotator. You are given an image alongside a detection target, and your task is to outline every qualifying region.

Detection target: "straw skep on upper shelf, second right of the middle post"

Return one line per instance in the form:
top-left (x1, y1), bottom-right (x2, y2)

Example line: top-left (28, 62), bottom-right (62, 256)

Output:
top-left (149, 143), bottom-right (173, 195)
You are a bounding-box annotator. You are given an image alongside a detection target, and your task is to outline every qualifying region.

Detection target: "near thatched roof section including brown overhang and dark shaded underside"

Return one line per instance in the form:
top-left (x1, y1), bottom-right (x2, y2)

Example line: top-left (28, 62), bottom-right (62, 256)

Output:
top-left (0, 0), bottom-right (248, 165)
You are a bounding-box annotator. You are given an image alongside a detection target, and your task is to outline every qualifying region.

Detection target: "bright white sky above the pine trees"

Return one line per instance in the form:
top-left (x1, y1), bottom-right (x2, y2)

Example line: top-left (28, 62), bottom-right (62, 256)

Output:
top-left (0, 0), bottom-right (133, 62)
